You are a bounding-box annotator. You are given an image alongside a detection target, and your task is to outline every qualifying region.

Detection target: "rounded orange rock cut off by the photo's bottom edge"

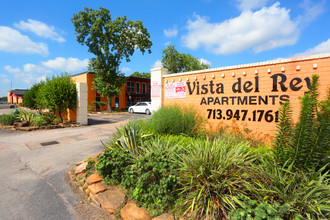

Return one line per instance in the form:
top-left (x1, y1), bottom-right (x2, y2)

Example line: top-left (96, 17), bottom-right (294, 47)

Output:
top-left (120, 200), bottom-right (152, 220)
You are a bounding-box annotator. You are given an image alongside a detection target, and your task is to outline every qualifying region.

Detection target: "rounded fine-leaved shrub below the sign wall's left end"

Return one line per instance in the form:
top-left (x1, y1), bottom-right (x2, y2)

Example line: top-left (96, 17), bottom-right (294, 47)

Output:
top-left (151, 105), bottom-right (203, 136)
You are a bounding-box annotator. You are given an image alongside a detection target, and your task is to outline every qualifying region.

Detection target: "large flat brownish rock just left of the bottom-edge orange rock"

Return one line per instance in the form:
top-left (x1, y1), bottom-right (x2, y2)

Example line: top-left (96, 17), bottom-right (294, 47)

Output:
top-left (97, 190), bottom-right (125, 214)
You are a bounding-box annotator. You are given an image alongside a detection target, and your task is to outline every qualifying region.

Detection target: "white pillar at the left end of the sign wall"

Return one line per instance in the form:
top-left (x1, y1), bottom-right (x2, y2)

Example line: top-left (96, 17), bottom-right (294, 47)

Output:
top-left (151, 67), bottom-right (168, 112)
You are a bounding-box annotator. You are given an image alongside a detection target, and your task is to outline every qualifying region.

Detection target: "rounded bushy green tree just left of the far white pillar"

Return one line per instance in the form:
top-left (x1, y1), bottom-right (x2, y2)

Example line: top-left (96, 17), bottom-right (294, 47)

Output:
top-left (38, 73), bottom-right (77, 122)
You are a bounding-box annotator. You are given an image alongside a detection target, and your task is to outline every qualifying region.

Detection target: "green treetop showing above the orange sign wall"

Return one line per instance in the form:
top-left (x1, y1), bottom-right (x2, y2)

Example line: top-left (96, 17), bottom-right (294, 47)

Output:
top-left (162, 45), bottom-right (210, 73)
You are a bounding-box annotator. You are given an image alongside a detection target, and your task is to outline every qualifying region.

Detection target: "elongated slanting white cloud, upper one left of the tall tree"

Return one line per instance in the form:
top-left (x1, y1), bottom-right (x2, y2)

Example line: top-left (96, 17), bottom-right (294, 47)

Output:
top-left (14, 19), bottom-right (65, 42)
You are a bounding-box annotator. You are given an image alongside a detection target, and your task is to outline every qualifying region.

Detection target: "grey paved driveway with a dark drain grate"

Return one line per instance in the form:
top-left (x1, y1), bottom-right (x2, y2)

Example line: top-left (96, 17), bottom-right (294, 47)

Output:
top-left (0, 114), bottom-right (146, 220)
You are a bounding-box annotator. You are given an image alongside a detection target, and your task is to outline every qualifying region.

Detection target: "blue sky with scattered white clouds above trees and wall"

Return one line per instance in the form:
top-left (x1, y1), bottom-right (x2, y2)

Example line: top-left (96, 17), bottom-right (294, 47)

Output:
top-left (0, 0), bottom-right (330, 97)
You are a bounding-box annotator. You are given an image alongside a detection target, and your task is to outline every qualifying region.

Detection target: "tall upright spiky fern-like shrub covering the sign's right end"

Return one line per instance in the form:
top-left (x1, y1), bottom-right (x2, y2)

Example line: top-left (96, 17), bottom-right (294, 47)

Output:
top-left (274, 75), bottom-right (330, 170)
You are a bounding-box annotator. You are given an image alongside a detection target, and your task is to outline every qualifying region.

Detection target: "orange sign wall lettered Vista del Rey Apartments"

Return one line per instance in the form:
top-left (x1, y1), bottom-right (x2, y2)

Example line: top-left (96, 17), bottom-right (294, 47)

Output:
top-left (162, 54), bottom-right (330, 134)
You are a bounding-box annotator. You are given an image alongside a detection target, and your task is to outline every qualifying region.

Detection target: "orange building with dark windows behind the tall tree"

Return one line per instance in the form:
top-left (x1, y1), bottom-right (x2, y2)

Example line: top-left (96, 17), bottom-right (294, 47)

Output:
top-left (71, 72), bottom-right (150, 111)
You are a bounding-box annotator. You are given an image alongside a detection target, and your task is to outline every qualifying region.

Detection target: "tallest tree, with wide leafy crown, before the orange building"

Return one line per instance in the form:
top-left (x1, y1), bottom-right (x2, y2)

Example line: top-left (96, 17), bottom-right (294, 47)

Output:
top-left (71, 7), bottom-right (152, 110)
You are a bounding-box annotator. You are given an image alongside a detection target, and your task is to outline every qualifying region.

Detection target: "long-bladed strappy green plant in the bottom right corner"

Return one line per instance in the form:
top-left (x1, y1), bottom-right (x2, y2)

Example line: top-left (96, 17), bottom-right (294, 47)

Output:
top-left (254, 158), bottom-right (330, 219)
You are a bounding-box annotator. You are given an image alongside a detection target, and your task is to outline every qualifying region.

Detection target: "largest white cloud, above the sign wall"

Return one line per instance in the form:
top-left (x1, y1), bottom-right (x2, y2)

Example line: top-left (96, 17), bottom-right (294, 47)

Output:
top-left (182, 2), bottom-right (300, 55)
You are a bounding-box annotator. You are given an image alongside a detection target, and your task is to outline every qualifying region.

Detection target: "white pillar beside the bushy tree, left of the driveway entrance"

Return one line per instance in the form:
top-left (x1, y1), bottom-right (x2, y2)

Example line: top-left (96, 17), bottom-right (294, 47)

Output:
top-left (76, 82), bottom-right (88, 125)
